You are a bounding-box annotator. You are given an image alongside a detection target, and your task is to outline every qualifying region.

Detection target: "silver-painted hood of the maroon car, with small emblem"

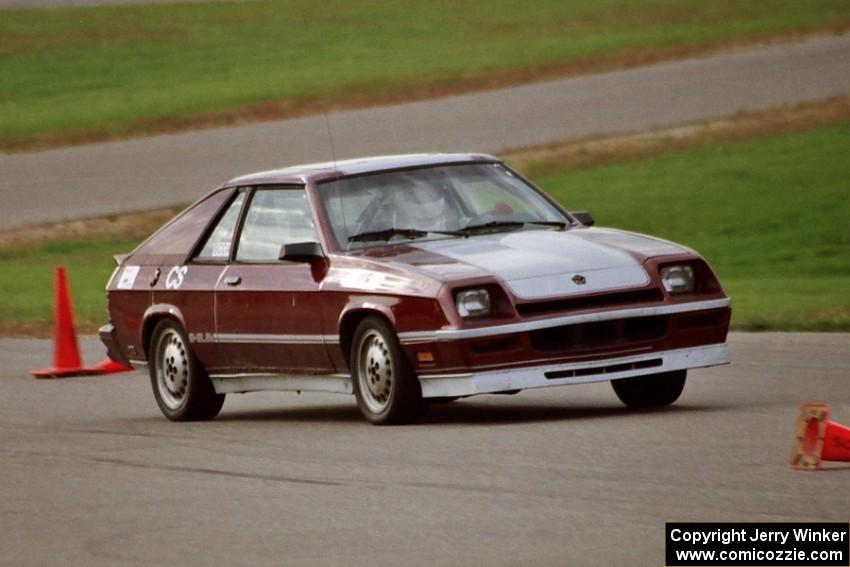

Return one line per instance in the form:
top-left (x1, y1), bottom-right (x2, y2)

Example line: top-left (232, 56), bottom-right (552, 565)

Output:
top-left (400, 229), bottom-right (687, 299)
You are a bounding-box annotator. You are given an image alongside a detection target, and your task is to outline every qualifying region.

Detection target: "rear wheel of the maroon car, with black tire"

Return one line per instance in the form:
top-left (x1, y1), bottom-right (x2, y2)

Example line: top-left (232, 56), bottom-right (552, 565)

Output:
top-left (148, 319), bottom-right (224, 421)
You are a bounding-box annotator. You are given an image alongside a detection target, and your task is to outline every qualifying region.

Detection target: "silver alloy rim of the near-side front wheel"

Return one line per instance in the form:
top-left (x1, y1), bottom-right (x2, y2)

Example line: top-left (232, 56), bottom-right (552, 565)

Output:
top-left (357, 329), bottom-right (393, 414)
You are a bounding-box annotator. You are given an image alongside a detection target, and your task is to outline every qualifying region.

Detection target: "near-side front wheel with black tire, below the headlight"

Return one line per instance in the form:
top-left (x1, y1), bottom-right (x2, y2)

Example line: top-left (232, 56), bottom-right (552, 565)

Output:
top-left (349, 316), bottom-right (427, 425)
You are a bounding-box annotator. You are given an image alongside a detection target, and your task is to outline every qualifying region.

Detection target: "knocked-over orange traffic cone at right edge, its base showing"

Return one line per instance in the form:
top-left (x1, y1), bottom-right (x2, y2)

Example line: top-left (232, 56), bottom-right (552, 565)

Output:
top-left (791, 404), bottom-right (850, 471)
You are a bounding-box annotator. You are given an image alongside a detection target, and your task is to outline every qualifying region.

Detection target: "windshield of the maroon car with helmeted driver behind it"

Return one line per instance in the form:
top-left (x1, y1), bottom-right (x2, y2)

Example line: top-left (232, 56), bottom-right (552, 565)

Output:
top-left (319, 163), bottom-right (569, 250)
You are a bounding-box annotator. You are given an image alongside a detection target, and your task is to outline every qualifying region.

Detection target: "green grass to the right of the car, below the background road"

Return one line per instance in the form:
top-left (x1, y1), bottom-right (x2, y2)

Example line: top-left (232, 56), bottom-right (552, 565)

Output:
top-left (538, 123), bottom-right (850, 331)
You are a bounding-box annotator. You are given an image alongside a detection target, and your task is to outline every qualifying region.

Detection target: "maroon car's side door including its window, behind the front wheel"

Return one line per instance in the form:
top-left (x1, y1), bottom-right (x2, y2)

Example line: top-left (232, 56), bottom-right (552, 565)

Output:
top-left (215, 186), bottom-right (332, 373)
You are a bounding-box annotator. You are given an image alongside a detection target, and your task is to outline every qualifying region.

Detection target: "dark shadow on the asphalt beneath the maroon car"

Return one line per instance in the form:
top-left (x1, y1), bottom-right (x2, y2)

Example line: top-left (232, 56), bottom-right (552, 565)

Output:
top-left (216, 401), bottom-right (723, 426)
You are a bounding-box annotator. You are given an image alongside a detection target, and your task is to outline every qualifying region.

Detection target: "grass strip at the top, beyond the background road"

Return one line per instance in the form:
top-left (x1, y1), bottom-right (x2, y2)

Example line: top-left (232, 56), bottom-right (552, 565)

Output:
top-left (0, 0), bottom-right (850, 150)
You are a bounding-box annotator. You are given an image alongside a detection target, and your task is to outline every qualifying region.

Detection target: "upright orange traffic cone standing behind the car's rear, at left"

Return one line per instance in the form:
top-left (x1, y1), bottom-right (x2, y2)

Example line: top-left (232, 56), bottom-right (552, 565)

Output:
top-left (31, 266), bottom-right (100, 378)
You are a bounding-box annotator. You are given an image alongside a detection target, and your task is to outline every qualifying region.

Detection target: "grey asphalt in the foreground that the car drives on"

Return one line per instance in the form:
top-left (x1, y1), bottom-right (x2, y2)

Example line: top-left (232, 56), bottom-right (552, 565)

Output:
top-left (0, 334), bottom-right (850, 567)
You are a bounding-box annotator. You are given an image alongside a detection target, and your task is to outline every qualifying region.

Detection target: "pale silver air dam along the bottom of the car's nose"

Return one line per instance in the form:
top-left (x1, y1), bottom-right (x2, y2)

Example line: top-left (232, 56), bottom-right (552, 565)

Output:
top-left (419, 344), bottom-right (729, 398)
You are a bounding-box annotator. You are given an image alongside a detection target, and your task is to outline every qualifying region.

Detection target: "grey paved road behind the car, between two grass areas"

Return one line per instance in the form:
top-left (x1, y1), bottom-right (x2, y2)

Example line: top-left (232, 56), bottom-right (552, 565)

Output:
top-left (0, 34), bottom-right (850, 228)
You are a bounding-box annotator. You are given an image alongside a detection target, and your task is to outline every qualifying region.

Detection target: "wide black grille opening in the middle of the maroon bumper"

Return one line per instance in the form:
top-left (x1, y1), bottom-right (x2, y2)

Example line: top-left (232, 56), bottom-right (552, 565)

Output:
top-left (528, 315), bottom-right (670, 352)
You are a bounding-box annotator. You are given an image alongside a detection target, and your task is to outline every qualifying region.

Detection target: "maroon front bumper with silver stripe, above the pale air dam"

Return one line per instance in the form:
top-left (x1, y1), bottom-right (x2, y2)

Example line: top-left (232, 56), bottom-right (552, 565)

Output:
top-left (399, 298), bottom-right (731, 378)
